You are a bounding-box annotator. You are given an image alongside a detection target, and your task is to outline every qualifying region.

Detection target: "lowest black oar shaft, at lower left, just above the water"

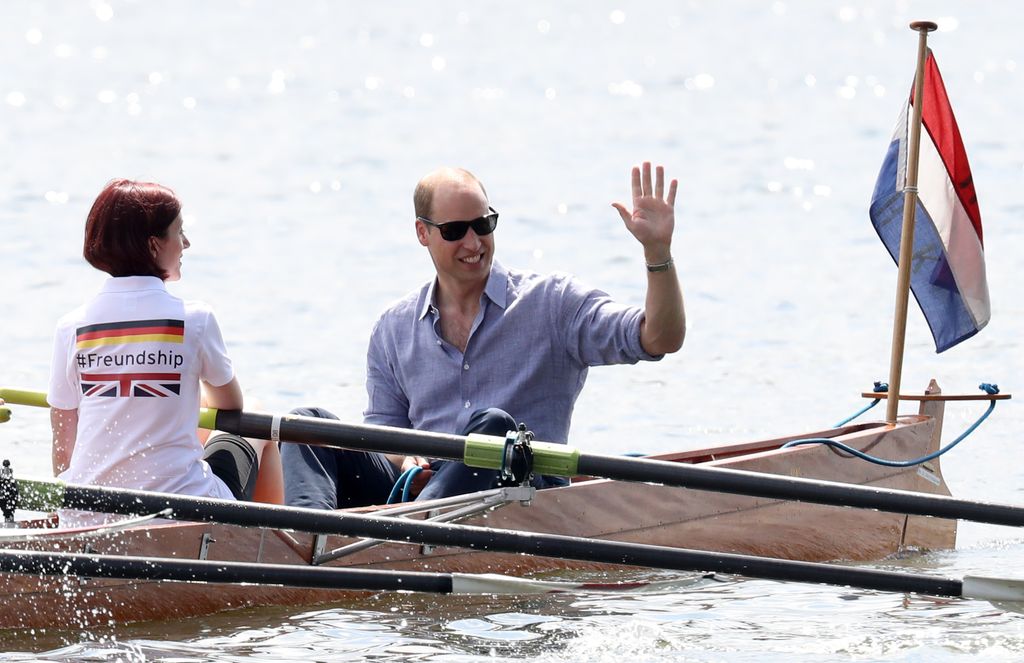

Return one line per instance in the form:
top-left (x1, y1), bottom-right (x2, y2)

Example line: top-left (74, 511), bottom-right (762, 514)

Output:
top-left (0, 550), bottom-right (452, 593)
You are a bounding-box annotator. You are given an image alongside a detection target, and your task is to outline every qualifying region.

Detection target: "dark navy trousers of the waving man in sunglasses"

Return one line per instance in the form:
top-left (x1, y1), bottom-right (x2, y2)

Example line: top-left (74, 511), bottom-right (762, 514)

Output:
top-left (281, 408), bottom-right (568, 509)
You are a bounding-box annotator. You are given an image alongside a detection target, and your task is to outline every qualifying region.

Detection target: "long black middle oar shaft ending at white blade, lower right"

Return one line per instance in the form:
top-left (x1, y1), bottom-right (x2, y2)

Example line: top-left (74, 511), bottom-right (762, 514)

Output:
top-left (56, 485), bottom-right (963, 596)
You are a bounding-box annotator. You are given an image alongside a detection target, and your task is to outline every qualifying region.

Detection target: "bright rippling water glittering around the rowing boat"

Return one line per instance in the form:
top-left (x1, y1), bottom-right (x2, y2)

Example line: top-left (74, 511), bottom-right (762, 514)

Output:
top-left (0, 0), bottom-right (1024, 661)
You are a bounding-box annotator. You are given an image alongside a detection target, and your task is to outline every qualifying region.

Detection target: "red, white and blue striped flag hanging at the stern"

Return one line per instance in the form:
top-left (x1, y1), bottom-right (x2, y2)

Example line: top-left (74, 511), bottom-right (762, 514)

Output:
top-left (869, 49), bottom-right (989, 353)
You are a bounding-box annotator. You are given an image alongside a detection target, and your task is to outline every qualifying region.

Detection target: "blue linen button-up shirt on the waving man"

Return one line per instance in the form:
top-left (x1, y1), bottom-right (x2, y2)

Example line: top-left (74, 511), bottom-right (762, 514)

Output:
top-left (362, 260), bottom-right (660, 444)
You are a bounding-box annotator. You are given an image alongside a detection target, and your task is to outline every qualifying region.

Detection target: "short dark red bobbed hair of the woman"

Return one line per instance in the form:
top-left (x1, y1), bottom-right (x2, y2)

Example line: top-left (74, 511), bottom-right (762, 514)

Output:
top-left (82, 179), bottom-right (181, 279)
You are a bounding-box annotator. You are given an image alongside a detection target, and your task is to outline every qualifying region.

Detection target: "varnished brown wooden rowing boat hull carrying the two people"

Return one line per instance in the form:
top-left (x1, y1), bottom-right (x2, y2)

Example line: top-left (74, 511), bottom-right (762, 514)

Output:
top-left (0, 389), bottom-right (956, 628)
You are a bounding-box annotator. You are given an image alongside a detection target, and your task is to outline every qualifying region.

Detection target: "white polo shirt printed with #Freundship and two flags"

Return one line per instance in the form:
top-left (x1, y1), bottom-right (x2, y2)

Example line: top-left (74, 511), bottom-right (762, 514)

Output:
top-left (47, 277), bottom-right (234, 499)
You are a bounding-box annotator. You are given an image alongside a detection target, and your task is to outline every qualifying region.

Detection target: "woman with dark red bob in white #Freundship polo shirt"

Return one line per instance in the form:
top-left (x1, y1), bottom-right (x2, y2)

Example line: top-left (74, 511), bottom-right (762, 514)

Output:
top-left (47, 179), bottom-right (283, 520)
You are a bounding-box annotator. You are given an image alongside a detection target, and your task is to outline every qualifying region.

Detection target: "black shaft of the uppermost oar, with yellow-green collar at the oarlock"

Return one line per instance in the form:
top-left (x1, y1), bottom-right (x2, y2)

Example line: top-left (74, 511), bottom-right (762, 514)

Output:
top-left (216, 411), bottom-right (1024, 527)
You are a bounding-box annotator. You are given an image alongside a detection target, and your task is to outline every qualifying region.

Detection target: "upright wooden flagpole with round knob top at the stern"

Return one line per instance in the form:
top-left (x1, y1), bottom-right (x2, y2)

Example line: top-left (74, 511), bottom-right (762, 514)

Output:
top-left (886, 20), bottom-right (938, 424)
